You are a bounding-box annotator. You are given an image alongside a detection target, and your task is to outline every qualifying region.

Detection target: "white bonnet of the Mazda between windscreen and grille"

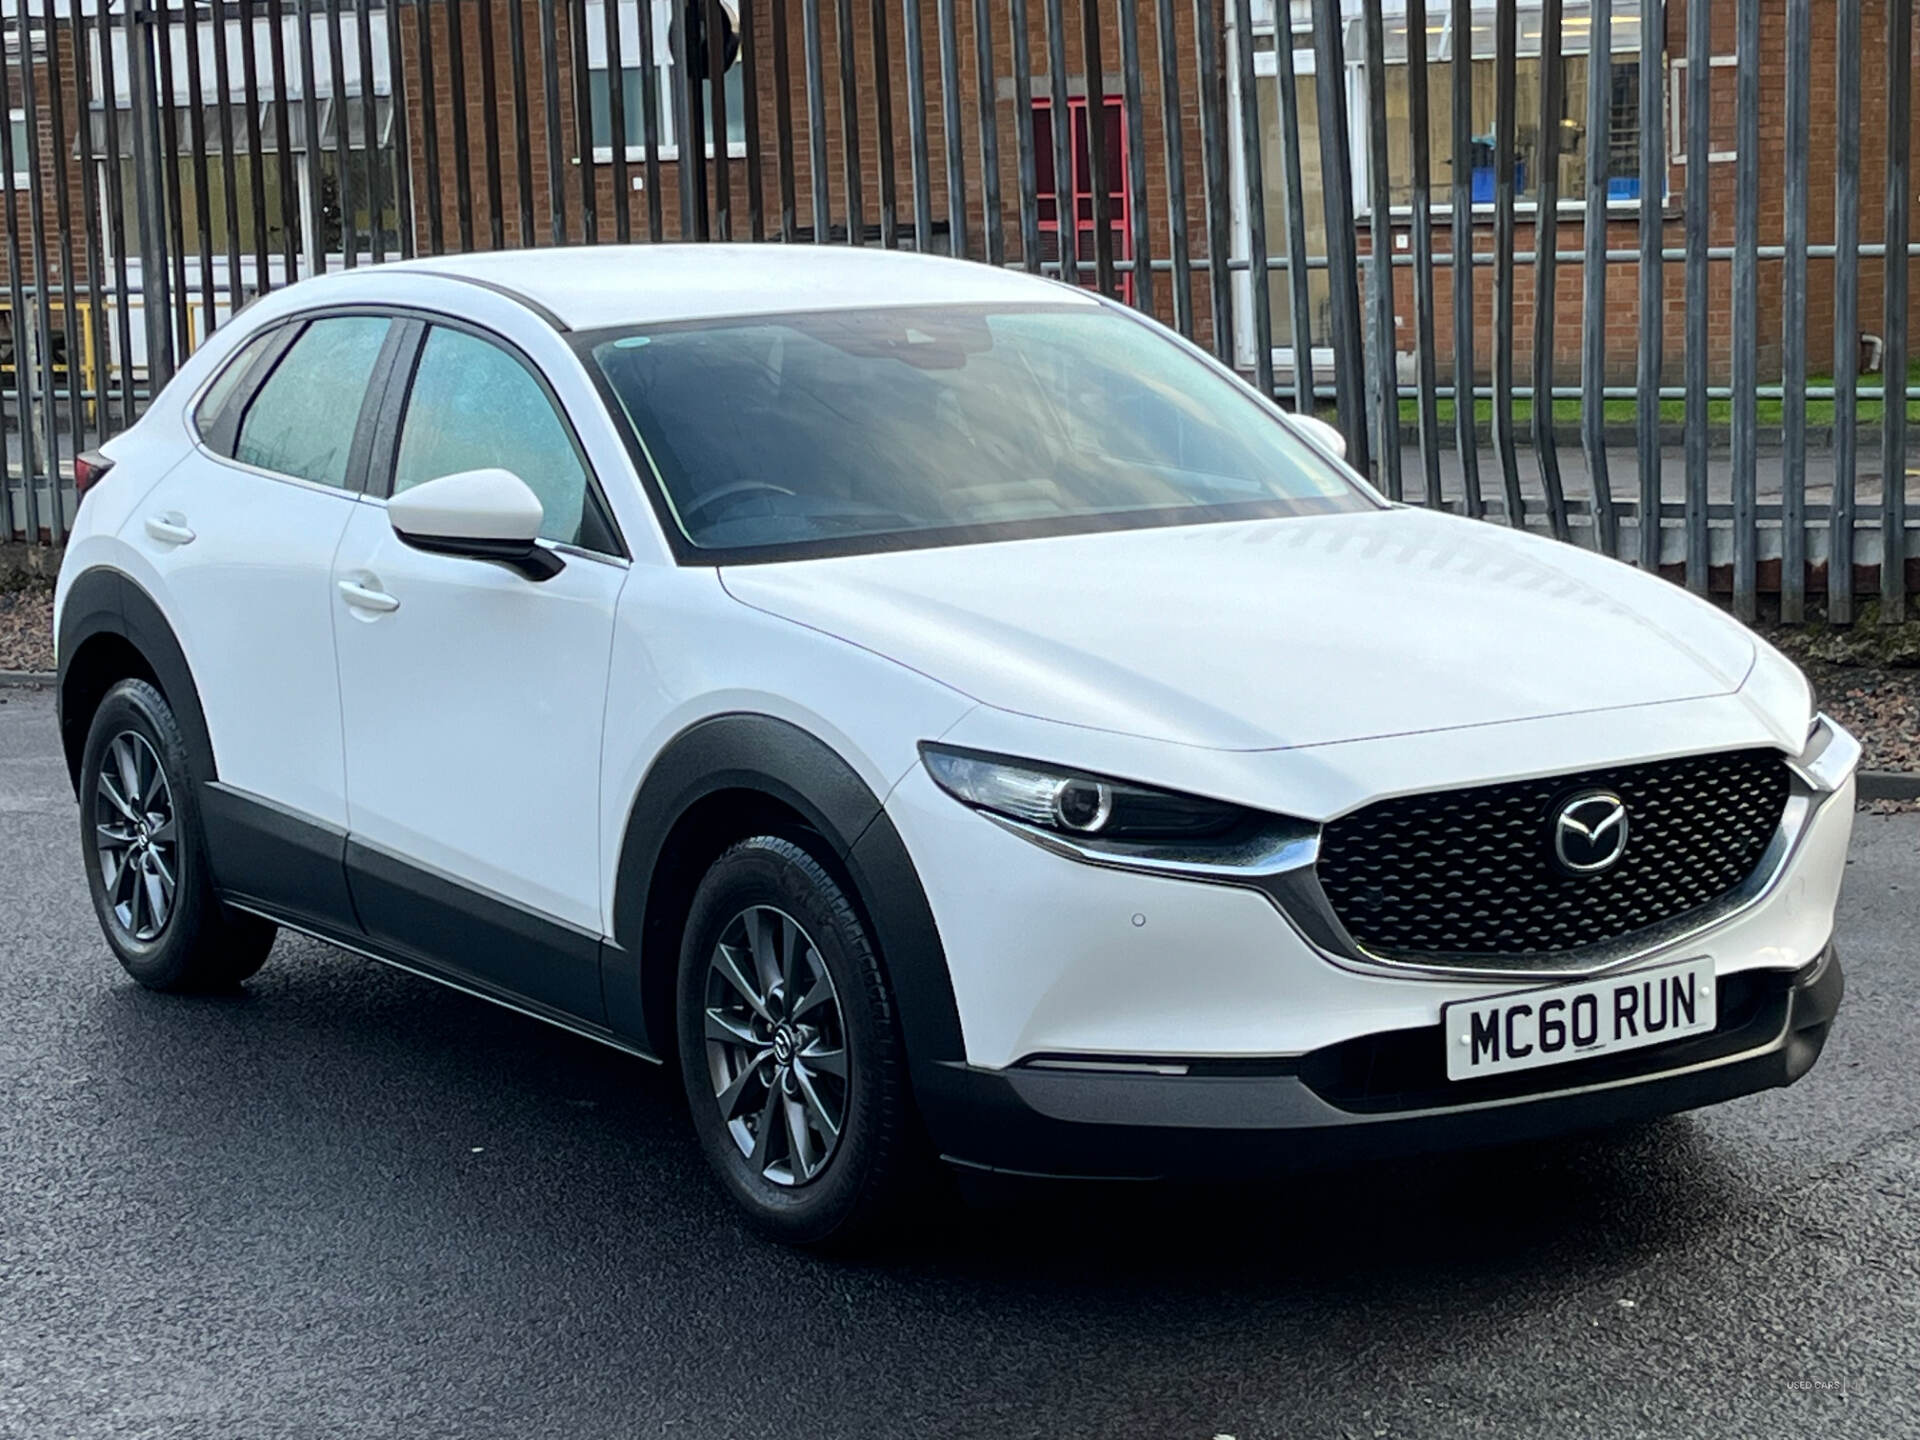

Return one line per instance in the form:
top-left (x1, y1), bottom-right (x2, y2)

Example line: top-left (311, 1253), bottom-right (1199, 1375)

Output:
top-left (722, 509), bottom-right (1755, 749)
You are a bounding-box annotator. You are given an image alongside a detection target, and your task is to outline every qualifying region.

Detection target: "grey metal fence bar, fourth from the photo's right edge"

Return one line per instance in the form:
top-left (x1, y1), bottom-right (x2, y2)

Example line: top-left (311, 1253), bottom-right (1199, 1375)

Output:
top-left (1734, 0), bottom-right (1761, 622)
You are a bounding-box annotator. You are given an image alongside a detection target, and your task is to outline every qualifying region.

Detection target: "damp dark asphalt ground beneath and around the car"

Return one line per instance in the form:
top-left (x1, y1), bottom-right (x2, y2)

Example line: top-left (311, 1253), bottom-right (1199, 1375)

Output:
top-left (0, 691), bottom-right (1920, 1440)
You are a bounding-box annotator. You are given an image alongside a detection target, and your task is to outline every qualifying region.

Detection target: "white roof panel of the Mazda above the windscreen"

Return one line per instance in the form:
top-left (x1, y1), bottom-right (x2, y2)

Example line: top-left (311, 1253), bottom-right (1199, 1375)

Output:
top-left (374, 244), bottom-right (1096, 330)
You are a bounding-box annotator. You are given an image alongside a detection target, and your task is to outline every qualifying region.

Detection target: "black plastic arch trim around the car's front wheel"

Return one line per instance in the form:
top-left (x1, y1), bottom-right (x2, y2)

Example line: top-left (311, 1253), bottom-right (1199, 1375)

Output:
top-left (607, 714), bottom-right (964, 1075)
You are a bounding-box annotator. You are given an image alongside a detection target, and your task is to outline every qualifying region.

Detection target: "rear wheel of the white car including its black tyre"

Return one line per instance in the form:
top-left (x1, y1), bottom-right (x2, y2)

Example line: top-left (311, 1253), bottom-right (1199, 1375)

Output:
top-left (81, 680), bottom-right (275, 991)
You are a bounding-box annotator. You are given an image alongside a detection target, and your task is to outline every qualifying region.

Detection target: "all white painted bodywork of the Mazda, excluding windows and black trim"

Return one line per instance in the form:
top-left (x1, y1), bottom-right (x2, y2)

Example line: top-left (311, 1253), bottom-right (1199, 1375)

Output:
top-left (61, 246), bottom-right (1853, 1105)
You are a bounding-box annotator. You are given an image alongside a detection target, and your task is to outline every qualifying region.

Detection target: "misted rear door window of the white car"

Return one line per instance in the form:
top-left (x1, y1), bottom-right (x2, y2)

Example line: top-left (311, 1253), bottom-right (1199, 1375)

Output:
top-left (234, 315), bottom-right (388, 488)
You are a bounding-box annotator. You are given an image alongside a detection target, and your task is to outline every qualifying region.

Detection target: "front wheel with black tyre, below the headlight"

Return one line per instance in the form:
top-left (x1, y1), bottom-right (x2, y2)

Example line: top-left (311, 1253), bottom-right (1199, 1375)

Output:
top-left (676, 835), bottom-right (927, 1248)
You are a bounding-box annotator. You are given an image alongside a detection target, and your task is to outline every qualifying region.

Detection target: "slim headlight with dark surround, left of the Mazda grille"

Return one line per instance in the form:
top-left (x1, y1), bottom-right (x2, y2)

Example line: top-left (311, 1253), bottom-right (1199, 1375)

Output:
top-left (920, 745), bottom-right (1250, 841)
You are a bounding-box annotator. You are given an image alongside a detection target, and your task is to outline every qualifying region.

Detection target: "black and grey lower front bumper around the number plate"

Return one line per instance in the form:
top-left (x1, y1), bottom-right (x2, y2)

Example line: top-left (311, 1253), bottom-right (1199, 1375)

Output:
top-left (916, 947), bottom-right (1845, 1179)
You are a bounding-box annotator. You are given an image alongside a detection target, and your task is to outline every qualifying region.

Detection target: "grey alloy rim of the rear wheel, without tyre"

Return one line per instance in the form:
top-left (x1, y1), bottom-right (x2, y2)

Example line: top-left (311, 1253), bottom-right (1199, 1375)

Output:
top-left (94, 730), bottom-right (180, 945)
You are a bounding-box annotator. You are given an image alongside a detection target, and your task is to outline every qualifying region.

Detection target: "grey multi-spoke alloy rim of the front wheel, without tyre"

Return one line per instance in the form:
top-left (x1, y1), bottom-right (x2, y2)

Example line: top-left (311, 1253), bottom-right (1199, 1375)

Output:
top-left (703, 904), bottom-right (849, 1187)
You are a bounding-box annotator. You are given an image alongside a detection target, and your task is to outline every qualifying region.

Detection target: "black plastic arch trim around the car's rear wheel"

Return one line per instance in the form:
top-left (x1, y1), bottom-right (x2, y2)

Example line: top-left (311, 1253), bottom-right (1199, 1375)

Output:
top-left (58, 568), bottom-right (219, 802)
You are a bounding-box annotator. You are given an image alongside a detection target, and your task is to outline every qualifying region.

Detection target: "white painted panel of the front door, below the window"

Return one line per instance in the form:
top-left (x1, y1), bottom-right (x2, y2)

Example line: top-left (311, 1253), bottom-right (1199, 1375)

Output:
top-left (332, 503), bottom-right (626, 933)
